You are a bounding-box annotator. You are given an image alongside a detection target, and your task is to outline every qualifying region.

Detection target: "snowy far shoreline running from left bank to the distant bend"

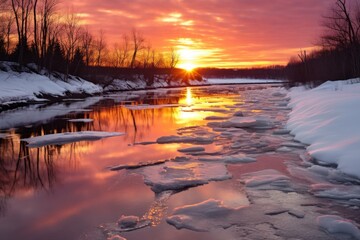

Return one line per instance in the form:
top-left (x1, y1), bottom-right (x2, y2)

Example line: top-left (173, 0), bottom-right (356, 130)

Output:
top-left (0, 62), bottom-right (282, 111)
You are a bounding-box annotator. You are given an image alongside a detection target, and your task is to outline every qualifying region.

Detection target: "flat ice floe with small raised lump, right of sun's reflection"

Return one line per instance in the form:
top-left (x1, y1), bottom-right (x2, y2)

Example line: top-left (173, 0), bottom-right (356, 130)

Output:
top-left (221, 116), bottom-right (274, 129)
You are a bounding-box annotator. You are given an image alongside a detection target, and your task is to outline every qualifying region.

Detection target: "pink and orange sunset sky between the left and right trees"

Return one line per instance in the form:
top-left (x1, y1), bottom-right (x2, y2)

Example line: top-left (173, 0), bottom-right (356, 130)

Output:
top-left (59, 0), bottom-right (333, 68)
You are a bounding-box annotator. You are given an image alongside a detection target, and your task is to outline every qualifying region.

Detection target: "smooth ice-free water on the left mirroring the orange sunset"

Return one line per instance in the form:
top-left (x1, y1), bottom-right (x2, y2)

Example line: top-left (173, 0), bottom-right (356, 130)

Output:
top-left (0, 87), bottom-right (272, 239)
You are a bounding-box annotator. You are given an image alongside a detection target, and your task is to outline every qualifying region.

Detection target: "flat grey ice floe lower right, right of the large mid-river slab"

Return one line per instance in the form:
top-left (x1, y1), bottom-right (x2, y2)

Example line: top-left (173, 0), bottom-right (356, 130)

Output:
top-left (241, 169), bottom-right (292, 191)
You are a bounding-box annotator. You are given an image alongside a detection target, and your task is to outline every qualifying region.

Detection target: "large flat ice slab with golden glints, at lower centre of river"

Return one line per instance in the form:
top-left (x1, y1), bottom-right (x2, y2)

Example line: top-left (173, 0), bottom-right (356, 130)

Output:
top-left (136, 162), bottom-right (231, 193)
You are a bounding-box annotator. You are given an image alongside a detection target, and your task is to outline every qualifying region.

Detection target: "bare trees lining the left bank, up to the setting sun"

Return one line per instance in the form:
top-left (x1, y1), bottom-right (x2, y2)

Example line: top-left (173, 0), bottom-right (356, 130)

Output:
top-left (0, 0), bottom-right (179, 78)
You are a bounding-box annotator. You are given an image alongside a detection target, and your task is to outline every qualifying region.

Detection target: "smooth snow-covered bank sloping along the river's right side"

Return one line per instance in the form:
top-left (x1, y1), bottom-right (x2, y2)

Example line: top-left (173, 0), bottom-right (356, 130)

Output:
top-left (287, 79), bottom-right (360, 178)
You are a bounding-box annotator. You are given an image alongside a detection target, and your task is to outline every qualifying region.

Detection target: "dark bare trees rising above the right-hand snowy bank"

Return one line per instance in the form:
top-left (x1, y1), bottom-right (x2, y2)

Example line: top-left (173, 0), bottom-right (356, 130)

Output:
top-left (286, 0), bottom-right (360, 85)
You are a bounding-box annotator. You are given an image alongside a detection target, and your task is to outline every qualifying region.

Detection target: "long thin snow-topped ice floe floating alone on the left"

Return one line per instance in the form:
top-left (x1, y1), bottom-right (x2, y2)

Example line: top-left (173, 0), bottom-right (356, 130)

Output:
top-left (21, 131), bottom-right (124, 148)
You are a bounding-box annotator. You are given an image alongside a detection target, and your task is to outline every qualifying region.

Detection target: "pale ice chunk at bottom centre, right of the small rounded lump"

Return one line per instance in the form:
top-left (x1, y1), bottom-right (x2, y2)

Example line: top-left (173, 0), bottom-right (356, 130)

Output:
top-left (166, 199), bottom-right (235, 232)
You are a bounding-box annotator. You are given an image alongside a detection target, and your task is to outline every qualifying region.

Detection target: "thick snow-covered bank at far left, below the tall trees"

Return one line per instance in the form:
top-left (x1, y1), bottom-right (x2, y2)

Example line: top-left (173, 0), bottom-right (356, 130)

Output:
top-left (0, 62), bottom-right (103, 105)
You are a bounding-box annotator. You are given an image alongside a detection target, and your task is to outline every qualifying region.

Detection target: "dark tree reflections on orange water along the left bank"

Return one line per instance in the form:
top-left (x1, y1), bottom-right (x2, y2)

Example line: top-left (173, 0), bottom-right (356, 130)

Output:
top-left (0, 88), bottom-right (180, 214)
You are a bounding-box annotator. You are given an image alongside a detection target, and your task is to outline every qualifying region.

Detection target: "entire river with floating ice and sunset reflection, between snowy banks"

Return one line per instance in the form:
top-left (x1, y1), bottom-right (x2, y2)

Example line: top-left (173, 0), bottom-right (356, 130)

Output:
top-left (0, 85), bottom-right (360, 240)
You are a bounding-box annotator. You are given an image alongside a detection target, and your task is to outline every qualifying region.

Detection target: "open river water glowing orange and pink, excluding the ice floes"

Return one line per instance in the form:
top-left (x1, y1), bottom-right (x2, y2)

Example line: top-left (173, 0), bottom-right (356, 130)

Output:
top-left (0, 85), bottom-right (358, 239)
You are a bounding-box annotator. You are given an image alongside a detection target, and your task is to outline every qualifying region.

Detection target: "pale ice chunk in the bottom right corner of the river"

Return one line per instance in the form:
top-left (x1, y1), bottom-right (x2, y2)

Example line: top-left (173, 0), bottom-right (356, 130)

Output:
top-left (317, 215), bottom-right (360, 239)
